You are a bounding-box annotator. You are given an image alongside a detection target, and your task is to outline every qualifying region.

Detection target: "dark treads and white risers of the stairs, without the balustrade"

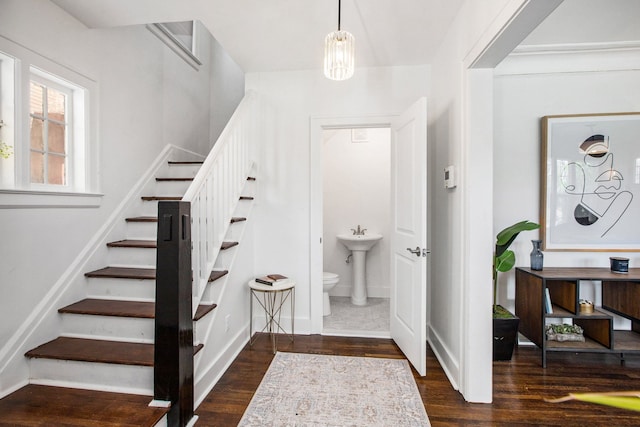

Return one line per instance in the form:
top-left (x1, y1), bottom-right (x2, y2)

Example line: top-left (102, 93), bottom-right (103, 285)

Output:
top-left (0, 162), bottom-right (254, 426)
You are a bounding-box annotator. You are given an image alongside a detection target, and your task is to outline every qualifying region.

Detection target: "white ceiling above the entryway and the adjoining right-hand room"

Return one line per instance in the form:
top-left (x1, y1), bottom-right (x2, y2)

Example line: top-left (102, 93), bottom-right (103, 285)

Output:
top-left (52, 0), bottom-right (640, 72)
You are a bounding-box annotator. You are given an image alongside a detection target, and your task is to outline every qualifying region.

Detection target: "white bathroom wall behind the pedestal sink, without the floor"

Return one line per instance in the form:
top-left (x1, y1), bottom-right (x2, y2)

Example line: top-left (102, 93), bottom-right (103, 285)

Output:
top-left (322, 128), bottom-right (391, 298)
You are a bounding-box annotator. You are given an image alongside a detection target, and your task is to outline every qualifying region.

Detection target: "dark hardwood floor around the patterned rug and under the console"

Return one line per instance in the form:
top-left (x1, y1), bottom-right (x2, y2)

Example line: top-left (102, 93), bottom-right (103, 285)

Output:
top-left (196, 335), bottom-right (640, 427)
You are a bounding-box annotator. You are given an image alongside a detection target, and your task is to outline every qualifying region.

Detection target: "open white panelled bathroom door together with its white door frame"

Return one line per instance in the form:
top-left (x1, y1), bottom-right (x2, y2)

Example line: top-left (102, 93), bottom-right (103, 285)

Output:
top-left (309, 98), bottom-right (428, 375)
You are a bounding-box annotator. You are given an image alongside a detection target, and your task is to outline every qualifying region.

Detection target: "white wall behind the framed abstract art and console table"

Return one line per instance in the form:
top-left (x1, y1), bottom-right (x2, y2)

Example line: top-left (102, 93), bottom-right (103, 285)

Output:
top-left (493, 50), bottom-right (640, 314)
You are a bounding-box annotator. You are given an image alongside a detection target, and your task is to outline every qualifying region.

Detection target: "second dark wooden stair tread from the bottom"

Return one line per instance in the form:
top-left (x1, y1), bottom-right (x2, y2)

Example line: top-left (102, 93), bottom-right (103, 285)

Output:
top-left (25, 337), bottom-right (204, 367)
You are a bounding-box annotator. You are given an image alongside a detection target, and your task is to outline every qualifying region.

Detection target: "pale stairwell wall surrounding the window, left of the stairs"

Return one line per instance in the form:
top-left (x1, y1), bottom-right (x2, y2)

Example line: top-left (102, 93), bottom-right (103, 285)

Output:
top-left (0, 0), bottom-right (244, 396)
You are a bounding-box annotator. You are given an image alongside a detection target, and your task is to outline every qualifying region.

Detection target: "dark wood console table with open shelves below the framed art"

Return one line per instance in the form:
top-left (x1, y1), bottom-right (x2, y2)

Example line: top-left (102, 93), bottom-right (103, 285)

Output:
top-left (516, 267), bottom-right (640, 367)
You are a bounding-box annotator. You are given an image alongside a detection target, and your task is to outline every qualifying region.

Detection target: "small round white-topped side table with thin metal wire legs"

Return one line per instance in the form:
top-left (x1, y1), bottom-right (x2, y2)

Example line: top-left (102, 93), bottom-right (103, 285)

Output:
top-left (249, 280), bottom-right (296, 354)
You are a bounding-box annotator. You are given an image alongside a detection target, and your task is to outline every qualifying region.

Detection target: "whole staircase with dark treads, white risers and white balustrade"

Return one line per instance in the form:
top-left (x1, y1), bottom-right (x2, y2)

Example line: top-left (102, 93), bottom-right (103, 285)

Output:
top-left (0, 94), bottom-right (264, 426)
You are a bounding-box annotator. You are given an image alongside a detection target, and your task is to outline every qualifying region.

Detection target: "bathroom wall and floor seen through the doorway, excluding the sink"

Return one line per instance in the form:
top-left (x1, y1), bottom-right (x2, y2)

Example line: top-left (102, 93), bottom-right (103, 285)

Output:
top-left (322, 127), bottom-right (391, 338)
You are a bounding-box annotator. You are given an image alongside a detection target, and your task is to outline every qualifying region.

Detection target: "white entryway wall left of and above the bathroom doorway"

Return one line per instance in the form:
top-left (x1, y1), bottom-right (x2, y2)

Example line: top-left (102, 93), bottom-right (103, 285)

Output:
top-left (246, 66), bottom-right (429, 333)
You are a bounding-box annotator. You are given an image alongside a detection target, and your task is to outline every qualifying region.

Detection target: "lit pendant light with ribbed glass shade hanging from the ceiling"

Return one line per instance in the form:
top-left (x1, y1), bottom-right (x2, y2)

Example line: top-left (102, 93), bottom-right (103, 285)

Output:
top-left (324, 0), bottom-right (355, 80)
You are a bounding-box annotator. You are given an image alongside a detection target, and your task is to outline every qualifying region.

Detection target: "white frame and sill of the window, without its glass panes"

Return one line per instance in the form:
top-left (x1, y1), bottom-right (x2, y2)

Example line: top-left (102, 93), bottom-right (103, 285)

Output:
top-left (0, 36), bottom-right (102, 209)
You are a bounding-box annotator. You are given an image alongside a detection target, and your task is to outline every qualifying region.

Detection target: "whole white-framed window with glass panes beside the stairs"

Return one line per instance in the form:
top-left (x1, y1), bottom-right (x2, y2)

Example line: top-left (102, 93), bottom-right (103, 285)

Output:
top-left (0, 37), bottom-right (101, 208)
